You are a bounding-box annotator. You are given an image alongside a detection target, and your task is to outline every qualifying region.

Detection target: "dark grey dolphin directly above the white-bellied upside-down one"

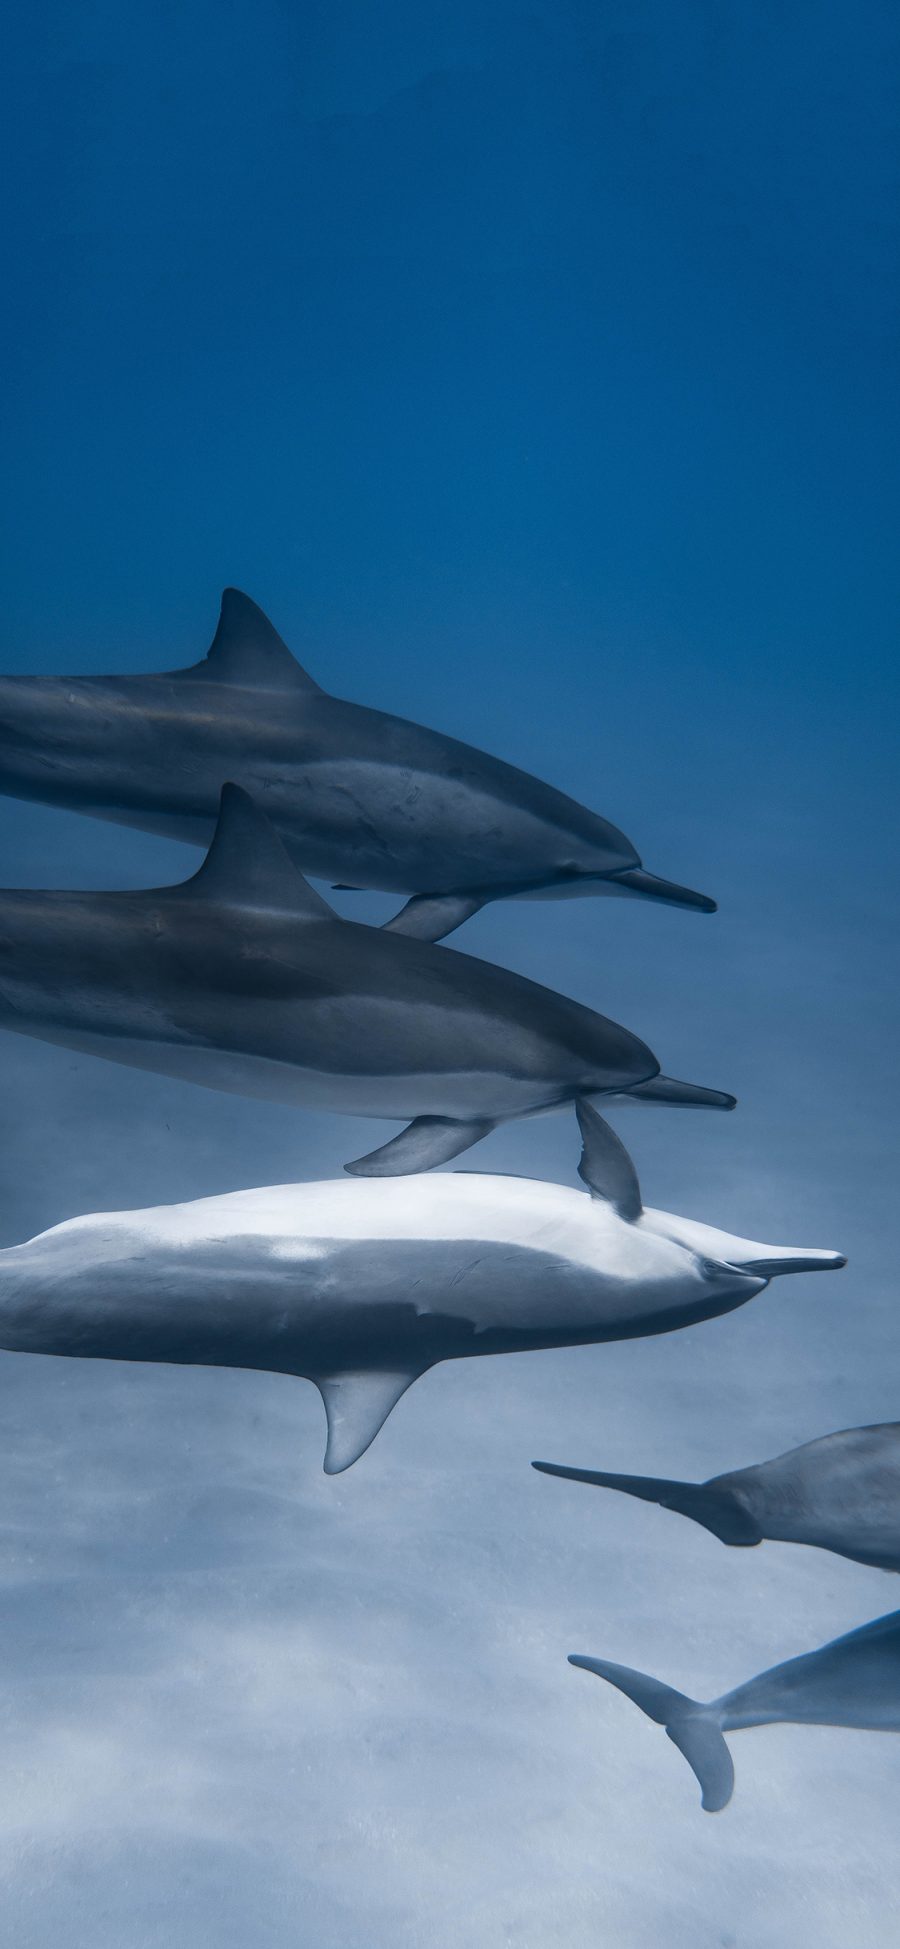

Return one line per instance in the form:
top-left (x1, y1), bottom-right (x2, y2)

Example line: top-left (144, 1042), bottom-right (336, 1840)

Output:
top-left (0, 785), bottom-right (734, 1175)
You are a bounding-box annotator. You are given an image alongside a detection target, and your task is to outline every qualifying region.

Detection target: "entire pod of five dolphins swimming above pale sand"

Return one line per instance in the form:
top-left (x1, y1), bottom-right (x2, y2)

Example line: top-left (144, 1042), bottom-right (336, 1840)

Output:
top-left (0, 589), bottom-right (872, 1811)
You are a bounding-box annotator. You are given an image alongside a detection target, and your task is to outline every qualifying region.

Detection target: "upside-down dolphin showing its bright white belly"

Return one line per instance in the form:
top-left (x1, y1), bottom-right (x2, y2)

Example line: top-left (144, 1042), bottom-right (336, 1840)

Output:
top-left (0, 1103), bottom-right (844, 1475)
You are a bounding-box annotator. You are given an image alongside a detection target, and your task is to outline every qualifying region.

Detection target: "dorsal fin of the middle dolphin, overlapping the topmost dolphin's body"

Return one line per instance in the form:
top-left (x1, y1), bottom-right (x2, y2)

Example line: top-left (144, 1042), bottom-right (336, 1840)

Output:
top-left (185, 785), bottom-right (339, 922)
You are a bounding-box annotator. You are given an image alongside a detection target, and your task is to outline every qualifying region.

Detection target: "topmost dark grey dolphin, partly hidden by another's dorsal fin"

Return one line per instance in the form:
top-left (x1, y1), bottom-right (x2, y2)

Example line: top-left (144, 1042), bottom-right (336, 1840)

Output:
top-left (0, 589), bottom-right (715, 941)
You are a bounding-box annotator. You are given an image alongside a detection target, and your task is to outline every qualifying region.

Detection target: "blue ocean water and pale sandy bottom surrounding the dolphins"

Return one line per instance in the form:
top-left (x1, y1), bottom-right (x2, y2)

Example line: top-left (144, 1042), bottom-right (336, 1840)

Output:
top-left (0, 0), bottom-right (900, 1949)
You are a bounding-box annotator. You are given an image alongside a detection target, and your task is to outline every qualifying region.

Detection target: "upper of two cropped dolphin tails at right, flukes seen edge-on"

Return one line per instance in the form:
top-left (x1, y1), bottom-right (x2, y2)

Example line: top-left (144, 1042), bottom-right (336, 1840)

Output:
top-left (532, 1426), bottom-right (900, 1571)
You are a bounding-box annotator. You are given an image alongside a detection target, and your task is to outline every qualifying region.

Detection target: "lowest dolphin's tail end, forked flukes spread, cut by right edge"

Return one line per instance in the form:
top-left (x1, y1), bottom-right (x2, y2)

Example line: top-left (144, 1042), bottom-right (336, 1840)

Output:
top-left (569, 1610), bottom-right (900, 1815)
